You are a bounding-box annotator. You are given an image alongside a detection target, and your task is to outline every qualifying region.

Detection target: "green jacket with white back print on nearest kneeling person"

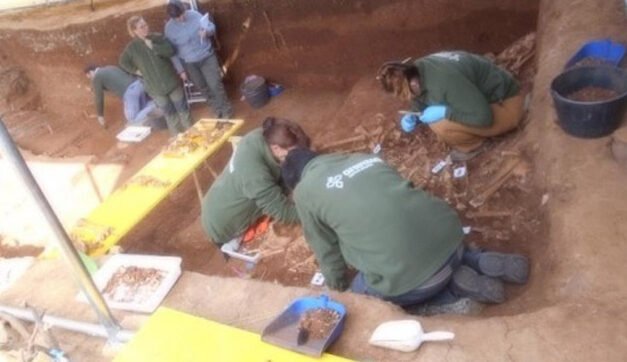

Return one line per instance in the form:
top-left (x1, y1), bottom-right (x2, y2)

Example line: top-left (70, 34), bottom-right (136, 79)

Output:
top-left (294, 154), bottom-right (463, 296)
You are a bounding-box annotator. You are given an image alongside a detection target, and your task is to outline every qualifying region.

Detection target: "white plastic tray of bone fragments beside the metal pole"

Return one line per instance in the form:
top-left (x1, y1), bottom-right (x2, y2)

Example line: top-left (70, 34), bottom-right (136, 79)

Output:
top-left (78, 254), bottom-right (181, 313)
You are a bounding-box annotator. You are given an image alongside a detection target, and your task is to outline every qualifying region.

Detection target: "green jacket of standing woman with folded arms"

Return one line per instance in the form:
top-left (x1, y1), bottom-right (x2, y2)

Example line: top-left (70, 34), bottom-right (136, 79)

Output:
top-left (120, 33), bottom-right (181, 96)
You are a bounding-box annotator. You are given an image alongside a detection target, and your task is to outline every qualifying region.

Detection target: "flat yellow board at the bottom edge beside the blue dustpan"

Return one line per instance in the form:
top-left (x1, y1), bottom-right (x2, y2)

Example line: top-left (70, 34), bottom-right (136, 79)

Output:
top-left (114, 307), bottom-right (351, 362)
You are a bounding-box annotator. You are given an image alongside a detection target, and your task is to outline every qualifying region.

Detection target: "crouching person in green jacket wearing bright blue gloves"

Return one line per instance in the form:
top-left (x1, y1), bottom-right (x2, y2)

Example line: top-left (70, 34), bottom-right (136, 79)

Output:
top-left (377, 51), bottom-right (524, 161)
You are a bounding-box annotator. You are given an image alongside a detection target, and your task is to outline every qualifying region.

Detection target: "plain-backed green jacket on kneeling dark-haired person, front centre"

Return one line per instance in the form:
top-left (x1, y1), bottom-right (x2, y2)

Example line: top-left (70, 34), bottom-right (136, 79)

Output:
top-left (201, 128), bottom-right (298, 244)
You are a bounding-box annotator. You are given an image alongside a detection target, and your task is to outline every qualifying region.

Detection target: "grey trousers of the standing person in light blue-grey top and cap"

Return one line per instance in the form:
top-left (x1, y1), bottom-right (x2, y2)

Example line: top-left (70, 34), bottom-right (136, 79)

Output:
top-left (185, 54), bottom-right (233, 118)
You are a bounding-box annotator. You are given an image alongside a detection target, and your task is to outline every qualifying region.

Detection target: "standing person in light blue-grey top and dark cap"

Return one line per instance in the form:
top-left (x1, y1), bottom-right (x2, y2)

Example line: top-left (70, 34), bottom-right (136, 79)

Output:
top-left (165, 0), bottom-right (233, 118)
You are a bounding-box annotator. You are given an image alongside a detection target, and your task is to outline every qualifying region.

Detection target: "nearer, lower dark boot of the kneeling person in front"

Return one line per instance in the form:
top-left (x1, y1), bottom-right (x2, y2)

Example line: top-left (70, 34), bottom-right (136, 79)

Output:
top-left (451, 265), bottom-right (505, 303)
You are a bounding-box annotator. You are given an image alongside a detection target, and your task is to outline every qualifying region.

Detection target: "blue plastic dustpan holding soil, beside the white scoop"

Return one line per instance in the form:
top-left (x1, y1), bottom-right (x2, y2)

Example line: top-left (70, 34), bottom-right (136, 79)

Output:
top-left (261, 294), bottom-right (346, 357)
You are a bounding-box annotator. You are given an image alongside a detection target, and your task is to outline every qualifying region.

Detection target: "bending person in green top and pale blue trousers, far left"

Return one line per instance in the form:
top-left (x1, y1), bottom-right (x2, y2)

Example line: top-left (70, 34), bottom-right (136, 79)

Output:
top-left (84, 64), bottom-right (163, 128)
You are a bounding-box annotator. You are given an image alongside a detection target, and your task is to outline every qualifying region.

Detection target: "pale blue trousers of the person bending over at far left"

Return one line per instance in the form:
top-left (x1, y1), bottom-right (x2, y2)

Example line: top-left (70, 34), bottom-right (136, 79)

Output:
top-left (123, 79), bottom-right (163, 126)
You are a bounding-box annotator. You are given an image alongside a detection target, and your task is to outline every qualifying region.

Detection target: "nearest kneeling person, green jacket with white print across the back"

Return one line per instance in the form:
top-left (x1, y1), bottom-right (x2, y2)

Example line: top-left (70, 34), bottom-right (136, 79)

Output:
top-left (282, 148), bottom-right (529, 306)
